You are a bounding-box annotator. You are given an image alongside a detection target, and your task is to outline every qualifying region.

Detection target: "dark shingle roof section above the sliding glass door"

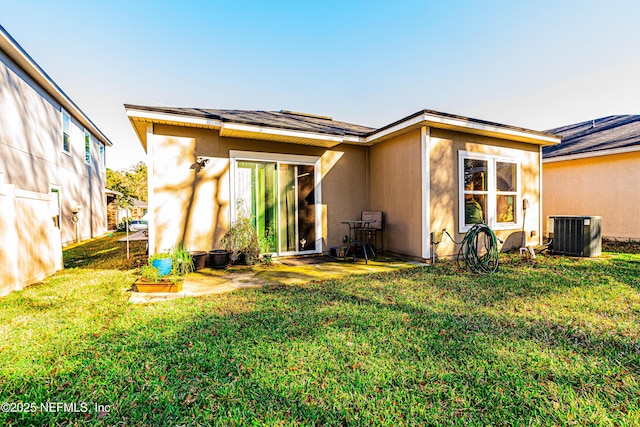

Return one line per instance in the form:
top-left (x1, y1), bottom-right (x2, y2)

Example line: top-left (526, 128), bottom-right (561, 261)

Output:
top-left (125, 105), bottom-right (374, 136)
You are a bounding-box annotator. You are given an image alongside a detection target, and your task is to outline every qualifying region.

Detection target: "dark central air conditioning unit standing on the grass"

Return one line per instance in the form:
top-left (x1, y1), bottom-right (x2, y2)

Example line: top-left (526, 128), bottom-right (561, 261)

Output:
top-left (549, 216), bottom-right (602, 257)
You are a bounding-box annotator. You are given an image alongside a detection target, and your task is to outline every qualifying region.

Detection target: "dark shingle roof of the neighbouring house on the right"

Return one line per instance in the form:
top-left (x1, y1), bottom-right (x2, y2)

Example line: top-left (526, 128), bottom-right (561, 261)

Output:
top-left (542, 115), bottom-right (640, 158)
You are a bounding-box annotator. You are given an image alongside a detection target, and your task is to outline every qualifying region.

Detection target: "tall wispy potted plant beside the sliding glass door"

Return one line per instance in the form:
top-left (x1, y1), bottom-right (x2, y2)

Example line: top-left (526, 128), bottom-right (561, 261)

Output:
top-left (220, 199), bottom-right (260, 265)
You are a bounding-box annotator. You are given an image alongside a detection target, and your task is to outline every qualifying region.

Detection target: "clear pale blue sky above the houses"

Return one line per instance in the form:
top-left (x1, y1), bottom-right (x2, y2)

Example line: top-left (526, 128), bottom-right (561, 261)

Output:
top-left (0, 0), bottom-right (640, 169)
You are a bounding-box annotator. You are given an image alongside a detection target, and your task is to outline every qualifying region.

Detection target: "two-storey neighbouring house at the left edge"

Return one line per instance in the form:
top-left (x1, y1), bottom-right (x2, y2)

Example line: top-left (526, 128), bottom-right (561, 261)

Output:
top-left (0, 27), bottom-right (111, 295)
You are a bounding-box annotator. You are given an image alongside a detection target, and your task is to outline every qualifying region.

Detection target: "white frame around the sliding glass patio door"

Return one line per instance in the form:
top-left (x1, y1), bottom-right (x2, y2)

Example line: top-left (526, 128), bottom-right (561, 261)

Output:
top-left (229, 150), bottom-right (323, 255)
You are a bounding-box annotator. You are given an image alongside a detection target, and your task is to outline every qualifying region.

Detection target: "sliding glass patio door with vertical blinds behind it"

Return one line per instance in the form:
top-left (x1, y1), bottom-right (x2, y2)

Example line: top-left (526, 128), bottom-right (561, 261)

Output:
top-left (231, 155), bottom-right (320, 254)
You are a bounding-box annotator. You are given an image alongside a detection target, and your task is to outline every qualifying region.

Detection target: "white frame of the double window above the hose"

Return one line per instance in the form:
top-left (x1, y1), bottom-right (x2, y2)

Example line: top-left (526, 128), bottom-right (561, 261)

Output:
top-left (458, 150), bottom-right (522, 233)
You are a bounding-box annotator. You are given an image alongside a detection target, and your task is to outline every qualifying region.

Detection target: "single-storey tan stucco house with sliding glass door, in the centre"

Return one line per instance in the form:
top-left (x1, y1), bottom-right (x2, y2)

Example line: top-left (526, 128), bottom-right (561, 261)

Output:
top-left (125, 105), bottom-right (560, 259)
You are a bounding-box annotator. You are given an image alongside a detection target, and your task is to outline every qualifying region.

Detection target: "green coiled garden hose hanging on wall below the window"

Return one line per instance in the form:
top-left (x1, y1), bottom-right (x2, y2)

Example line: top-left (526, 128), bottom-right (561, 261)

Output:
top-left (447, 224), bottom-right (499, 273)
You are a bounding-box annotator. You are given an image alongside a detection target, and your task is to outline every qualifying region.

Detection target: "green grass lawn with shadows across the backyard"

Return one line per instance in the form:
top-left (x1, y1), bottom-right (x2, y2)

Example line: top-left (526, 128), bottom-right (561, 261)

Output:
top-left (0, 238), bottom-right (640, 426)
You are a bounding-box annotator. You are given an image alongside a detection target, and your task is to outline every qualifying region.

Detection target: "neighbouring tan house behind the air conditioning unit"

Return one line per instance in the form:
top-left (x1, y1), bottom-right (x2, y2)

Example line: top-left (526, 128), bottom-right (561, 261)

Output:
top-left (542, 115), bottom-right (640, 240)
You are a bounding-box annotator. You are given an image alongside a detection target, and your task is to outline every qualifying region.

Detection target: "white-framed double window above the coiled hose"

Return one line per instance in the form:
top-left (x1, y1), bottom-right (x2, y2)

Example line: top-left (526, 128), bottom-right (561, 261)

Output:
top-left (458, 151), bottom-right (520, 232)
